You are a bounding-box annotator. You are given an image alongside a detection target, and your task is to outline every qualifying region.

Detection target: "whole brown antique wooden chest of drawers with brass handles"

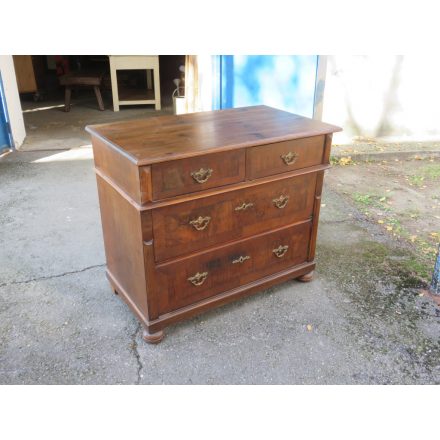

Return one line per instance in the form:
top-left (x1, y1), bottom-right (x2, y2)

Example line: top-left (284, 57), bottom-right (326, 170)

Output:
top-left (87, 106), bottom-right (340, 342)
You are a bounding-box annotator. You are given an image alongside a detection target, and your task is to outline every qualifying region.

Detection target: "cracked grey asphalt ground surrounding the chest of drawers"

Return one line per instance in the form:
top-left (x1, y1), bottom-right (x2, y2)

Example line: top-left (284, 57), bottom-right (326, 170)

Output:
top-left (0, 148), bottom-right (440, 384)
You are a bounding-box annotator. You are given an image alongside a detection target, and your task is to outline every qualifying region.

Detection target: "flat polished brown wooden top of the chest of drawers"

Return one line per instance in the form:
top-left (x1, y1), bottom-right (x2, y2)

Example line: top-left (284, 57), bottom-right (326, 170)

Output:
top-left (86, 105), bottom-right (341, 166)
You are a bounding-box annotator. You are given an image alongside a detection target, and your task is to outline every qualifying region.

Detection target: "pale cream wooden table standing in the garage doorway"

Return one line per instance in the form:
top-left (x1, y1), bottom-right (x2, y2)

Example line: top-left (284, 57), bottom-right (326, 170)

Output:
top-left (109, 55), bottom-right (161, 112)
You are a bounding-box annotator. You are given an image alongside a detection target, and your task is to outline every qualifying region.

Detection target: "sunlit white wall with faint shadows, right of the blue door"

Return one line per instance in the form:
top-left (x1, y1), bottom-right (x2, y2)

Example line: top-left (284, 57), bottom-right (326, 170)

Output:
top-left (322, 54), bottom-right (440, 143)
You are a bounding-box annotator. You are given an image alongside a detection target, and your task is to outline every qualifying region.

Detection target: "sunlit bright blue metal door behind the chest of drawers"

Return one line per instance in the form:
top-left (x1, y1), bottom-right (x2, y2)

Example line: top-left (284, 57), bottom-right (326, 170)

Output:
top-left (214, 55), bottom-right (318, 117)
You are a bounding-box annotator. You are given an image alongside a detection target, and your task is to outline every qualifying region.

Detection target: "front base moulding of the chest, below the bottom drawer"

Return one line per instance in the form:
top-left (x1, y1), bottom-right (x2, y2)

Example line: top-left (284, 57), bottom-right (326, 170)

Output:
top-left (147, 262), bottom-right (315, 332)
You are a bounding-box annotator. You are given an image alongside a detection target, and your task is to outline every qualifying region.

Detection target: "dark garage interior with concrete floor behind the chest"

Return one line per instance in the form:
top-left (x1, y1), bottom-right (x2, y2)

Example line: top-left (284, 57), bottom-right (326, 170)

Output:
top-left (13, 55), bottom-right (185, 151)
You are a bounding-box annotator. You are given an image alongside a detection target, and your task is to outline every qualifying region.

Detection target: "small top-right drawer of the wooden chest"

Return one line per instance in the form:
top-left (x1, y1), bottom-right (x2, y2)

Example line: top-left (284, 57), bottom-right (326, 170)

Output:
top-left (246, 136), bottom-right (324, 179)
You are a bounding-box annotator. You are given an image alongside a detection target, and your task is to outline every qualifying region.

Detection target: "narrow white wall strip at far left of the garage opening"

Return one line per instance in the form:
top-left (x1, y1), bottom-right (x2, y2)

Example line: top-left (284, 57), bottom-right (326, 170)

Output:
top-left (0, 55), bottom-right (26, 149)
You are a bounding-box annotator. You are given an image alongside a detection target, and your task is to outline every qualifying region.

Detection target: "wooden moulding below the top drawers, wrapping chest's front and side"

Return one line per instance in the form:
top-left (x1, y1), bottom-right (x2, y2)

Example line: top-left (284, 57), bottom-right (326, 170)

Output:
top-left (94, 164), bottom-right (330, 211)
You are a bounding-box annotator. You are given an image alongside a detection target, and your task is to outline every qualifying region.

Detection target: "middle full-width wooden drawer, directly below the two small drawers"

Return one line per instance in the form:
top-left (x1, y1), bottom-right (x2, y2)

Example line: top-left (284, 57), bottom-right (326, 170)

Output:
top-left (153, 173), bottom-right (318, 261)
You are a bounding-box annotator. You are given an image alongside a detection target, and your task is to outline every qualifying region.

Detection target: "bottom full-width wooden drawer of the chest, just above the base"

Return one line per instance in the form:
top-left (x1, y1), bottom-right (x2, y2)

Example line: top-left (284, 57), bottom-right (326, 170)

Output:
top-left (156, 221), bottom-right (311, 314)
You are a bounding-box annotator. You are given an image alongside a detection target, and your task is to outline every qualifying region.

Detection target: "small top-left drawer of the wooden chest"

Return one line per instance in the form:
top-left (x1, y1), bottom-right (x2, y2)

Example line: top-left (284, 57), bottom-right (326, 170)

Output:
top-left (151, 150), bottom-right (245, 200)
